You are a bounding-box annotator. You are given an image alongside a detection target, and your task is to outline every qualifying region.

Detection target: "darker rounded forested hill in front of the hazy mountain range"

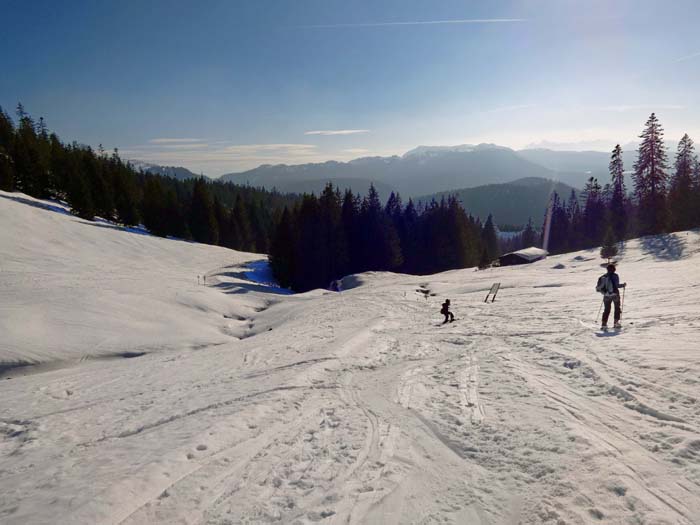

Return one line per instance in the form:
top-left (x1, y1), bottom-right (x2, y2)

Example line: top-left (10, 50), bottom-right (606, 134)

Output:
top-left (417, 177), bottom-right (574, 228)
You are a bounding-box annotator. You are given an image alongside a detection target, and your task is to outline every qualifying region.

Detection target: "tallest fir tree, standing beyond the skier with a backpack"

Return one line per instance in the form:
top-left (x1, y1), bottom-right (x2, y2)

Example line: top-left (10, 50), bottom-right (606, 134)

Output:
top-left (633, 113), bottom-right (668, 234)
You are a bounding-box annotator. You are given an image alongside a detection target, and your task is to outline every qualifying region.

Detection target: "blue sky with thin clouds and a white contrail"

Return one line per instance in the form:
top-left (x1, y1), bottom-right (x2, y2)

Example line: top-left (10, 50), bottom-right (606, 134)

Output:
top-left (0, 0), bottom-right (700, 175)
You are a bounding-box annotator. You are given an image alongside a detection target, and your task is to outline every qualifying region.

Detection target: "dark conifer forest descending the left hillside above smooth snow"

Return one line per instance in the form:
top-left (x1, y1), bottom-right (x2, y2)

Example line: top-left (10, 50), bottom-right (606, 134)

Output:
top-left (0, 104), bottom-right (298, 253)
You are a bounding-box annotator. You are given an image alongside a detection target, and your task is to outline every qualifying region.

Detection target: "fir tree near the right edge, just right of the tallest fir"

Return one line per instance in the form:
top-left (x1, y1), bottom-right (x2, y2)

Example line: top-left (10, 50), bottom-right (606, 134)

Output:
top-left (668, 133), bottom-right (697, 230)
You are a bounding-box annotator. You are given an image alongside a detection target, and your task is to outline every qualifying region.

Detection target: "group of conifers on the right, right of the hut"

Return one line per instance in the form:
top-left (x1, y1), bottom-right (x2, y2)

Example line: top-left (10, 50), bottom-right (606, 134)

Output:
top-left (542, 113), bottom-right (700, 254)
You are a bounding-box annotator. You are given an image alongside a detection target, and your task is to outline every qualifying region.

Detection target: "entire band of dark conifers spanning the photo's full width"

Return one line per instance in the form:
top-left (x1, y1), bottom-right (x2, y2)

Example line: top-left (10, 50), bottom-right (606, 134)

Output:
top-left (6, 104), bottom-right (700, 291)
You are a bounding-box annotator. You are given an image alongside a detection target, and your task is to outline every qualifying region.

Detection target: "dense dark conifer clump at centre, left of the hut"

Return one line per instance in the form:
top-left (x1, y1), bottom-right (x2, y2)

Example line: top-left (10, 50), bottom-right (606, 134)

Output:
top-left (270, 183), bottom-right (498, 291)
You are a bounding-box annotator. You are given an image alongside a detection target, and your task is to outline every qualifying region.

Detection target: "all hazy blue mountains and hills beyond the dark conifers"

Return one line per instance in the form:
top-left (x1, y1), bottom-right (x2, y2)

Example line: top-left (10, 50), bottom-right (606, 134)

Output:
top-left (131, 143), bottom-right (656, 224)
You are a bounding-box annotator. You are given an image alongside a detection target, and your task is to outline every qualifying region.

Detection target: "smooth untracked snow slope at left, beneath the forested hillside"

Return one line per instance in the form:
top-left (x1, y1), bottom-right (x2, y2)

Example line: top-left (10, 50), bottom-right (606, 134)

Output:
top-left (0, 192), bottom-right (261, 366)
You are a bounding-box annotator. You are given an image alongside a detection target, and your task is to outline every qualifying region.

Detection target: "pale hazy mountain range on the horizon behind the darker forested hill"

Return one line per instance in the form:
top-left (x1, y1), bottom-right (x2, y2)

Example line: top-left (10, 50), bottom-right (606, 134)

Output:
top-left (221, 144), bottom-right (635, 197)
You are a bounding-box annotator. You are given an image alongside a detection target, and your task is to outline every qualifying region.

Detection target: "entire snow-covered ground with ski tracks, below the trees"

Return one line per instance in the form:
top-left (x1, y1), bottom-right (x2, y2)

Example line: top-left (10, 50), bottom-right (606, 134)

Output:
top-left (0, 190), bottom-right (700, 524)
